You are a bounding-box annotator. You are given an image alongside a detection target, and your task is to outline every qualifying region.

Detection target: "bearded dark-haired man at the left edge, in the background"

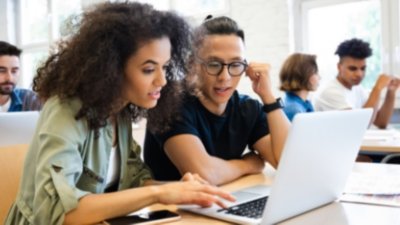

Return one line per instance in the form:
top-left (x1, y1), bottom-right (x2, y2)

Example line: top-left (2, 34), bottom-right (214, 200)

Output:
top-left (0, 41), bottom-right (41, 112)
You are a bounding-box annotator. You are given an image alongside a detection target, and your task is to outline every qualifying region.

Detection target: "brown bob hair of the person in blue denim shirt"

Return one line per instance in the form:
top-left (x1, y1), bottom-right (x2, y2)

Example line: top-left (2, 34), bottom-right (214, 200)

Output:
top-left (279, 53), bottom-right (318, 92)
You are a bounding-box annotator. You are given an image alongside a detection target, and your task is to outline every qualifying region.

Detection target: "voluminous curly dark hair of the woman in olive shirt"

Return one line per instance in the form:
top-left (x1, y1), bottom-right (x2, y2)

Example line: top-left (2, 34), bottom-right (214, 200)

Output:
top-left (33, 2), bottom-right (191, 134)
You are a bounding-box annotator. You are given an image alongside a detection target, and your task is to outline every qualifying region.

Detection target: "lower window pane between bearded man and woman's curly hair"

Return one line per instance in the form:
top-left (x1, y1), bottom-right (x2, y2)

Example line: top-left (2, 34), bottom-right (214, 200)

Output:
top-left (18, 50), bottom-right (48, 88)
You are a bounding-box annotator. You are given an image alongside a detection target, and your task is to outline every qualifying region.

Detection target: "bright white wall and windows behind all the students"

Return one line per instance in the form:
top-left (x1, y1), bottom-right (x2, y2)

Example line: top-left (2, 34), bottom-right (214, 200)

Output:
top-left (0, 0), bottom-right (400, 103)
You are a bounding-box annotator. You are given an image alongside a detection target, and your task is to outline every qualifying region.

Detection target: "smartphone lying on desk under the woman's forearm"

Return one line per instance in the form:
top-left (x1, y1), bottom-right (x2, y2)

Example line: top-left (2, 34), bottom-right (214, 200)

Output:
top-left (104, 210), bottom-right (181, 225)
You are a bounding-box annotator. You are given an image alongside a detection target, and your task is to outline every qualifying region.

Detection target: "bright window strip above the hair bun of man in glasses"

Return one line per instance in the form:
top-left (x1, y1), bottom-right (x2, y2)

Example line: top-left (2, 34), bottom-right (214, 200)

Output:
top-left (172, 0), bottom-right (227, 17)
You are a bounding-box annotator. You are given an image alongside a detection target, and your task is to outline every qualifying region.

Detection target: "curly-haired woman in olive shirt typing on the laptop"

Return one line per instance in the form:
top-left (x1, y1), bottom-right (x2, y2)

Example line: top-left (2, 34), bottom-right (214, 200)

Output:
top-left (5, 3), bottom-right (232, 225)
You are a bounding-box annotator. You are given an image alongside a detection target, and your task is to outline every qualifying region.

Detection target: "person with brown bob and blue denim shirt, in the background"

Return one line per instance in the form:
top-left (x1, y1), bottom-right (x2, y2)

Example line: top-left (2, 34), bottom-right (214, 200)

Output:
top-left (279, 53), bottom-right (320, 121)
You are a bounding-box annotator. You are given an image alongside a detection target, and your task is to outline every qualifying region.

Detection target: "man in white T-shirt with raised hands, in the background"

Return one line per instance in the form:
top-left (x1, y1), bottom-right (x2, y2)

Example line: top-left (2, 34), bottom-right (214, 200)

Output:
top-left (314, 38), bottom-right (400, 128)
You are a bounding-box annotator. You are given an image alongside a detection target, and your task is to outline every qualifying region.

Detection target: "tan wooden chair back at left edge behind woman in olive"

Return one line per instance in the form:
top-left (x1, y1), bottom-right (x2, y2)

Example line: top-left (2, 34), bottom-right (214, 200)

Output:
top-left (0, 144), bottom-right (28, 224)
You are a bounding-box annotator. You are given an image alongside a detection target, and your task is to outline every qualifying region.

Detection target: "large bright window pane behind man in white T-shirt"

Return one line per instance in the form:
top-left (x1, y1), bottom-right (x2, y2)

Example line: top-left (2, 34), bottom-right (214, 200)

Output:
top-left (306, 0), bottom-right (382, 88)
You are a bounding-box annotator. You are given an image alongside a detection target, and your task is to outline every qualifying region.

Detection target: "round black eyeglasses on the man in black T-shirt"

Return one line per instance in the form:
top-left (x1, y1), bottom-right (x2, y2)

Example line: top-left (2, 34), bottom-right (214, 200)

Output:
top-left (198, 58), bottom-right (248, 77)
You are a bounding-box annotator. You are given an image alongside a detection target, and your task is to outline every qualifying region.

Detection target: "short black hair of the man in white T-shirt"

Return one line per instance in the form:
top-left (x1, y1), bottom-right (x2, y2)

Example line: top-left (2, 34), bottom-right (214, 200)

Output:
top-left (335, 38), bottom-right (372, 59)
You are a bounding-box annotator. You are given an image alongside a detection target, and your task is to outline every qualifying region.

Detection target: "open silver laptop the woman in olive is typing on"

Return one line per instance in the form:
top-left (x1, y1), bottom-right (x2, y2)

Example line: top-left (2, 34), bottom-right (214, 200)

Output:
top-left (181, 109), bottom-right (372, 225)
